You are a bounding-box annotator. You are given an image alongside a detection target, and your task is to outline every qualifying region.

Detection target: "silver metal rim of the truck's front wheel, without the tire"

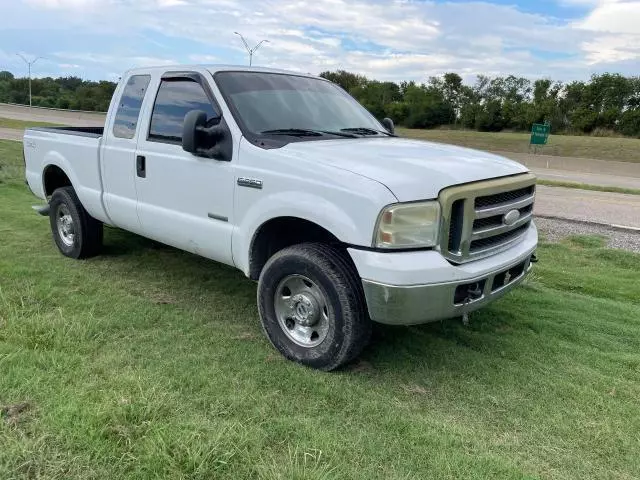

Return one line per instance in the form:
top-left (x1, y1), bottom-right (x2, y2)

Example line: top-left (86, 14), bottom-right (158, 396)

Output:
top-left (274, 275), bottom-right (329, 348)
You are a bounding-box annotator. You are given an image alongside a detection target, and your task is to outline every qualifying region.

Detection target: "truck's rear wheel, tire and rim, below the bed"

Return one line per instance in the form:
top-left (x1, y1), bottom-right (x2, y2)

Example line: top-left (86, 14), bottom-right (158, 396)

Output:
top-left (49, 187), bottom-right (103, 259)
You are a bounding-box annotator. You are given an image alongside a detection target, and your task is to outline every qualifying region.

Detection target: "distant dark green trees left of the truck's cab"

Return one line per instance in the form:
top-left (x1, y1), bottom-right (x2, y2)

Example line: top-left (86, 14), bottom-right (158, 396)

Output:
top-left (0, 71), bottom-right (116, 112)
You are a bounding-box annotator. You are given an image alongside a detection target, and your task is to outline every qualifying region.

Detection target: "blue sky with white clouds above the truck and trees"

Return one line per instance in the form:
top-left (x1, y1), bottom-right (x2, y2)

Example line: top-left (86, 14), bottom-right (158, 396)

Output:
top-left (0, 0), bottom-right (640, 82)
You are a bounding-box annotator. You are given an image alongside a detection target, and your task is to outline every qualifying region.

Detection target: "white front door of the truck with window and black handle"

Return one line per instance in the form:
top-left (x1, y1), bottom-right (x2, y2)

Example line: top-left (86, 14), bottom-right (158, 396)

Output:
top-left (135, 72), bottom-right (234, 265)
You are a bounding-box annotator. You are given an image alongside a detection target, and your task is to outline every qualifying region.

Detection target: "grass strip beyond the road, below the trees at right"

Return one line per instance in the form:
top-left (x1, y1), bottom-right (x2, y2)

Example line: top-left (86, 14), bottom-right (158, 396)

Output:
top-left (397, 128), bottom-right (640, 162)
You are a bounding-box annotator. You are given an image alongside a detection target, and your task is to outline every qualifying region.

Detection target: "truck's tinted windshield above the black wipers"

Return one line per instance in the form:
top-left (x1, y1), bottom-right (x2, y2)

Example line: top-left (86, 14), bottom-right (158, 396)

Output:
top-left (215, 72), bottom-right (384, 137)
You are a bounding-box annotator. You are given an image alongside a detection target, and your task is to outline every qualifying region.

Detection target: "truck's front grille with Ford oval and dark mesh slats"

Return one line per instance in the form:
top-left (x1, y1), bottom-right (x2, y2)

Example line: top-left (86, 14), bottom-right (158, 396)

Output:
top-left (439, 174), bottom-right (535, 263)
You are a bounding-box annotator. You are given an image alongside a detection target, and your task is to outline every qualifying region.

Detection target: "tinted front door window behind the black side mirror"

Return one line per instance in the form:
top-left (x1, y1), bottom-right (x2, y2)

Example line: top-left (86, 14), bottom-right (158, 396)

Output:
top-left (149, 79), bottom-right (218, 142)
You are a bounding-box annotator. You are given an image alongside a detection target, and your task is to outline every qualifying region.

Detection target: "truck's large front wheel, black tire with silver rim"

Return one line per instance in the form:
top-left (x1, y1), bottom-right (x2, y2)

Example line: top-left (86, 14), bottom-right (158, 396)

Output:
top-left (258, 243), bottom-right (371, 371)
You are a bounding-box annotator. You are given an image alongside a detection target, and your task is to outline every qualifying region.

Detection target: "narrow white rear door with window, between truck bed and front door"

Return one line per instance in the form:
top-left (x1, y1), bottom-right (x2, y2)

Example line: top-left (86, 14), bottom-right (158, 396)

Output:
top-left (102, 75), bottom-right (151, 232)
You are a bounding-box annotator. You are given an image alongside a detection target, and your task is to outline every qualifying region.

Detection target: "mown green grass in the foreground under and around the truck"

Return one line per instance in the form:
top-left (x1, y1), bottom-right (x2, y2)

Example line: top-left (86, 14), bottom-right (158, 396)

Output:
top-left (0, 138), bottom-right (640, 479)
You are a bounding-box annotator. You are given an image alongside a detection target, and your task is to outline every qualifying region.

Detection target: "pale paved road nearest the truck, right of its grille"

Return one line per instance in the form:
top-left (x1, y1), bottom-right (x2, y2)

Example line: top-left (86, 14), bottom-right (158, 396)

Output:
top-left (534, 185), bottom-right (640, 228)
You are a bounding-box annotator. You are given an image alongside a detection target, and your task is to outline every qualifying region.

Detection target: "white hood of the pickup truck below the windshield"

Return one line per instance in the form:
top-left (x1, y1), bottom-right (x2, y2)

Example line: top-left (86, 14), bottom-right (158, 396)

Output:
top-left (281, 137), bottom-right (528, 202)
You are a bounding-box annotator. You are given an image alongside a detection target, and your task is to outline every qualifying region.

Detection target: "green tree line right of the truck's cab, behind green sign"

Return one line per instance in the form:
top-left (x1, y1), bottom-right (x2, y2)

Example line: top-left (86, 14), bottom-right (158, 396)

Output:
top-left (320, 70), bottom-right (640, 137)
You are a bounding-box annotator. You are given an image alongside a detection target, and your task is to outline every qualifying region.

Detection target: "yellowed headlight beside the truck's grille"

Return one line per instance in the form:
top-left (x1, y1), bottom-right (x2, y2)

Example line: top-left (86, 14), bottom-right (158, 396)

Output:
top-left (373, 201), bottom-right (440, 248)
